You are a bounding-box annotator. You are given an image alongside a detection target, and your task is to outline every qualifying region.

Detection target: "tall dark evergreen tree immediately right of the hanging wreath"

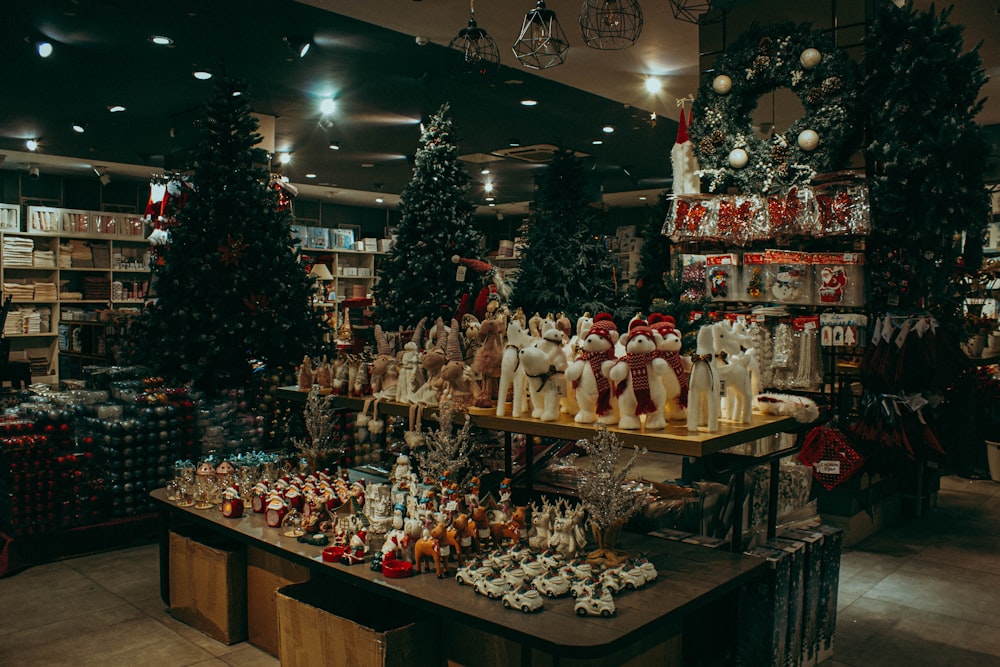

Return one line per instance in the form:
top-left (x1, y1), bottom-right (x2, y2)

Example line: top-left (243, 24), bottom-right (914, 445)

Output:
top-left (864, 3), bottom-right (989, 329)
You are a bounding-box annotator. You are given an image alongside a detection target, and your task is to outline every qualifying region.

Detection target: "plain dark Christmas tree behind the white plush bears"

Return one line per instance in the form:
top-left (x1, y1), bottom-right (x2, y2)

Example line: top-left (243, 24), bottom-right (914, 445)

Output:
top-left (511, 150), bottom-right (617, 317)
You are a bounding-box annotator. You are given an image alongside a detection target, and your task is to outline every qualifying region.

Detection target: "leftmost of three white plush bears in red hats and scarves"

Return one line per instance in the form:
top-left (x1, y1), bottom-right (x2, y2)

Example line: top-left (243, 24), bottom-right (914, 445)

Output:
top-left (566, 313), bottom-right (618, 424)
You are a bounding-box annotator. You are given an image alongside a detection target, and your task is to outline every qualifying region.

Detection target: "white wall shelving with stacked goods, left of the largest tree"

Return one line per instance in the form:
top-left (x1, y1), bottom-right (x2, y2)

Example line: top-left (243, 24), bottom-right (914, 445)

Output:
top-left (0, 204), bottom-right (150, 385)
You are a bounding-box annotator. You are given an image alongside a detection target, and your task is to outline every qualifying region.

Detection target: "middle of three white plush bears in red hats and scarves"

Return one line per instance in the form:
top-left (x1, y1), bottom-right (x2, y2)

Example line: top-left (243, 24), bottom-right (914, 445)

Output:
top-left (608, 320), bottom-right (667, 431)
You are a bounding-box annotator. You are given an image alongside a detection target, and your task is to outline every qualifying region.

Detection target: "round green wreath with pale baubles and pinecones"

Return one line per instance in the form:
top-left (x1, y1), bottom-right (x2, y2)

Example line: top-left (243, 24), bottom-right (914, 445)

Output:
top-left (690, 24), bottom-right (858, 193)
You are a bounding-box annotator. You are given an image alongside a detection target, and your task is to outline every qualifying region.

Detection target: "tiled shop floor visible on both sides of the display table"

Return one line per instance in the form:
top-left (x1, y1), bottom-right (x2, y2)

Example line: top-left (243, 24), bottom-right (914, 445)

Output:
top-left (0, 477), bottom-right (1000, 667)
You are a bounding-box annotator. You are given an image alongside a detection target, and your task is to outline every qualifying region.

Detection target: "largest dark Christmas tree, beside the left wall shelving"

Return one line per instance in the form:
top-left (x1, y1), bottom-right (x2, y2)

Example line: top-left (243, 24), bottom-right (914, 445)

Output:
top-left (135, 79), bottom-right (322, 392)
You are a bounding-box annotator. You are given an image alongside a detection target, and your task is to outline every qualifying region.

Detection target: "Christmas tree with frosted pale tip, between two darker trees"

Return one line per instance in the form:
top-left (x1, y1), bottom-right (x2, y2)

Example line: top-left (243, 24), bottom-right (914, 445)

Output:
top-left (374, 104), bottom-right (482, 329)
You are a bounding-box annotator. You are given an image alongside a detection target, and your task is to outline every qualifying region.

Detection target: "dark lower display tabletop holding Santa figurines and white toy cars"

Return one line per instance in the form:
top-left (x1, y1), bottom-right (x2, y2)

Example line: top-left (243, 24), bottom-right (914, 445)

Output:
top-left (151, 489), bottom-right (764, 664)
